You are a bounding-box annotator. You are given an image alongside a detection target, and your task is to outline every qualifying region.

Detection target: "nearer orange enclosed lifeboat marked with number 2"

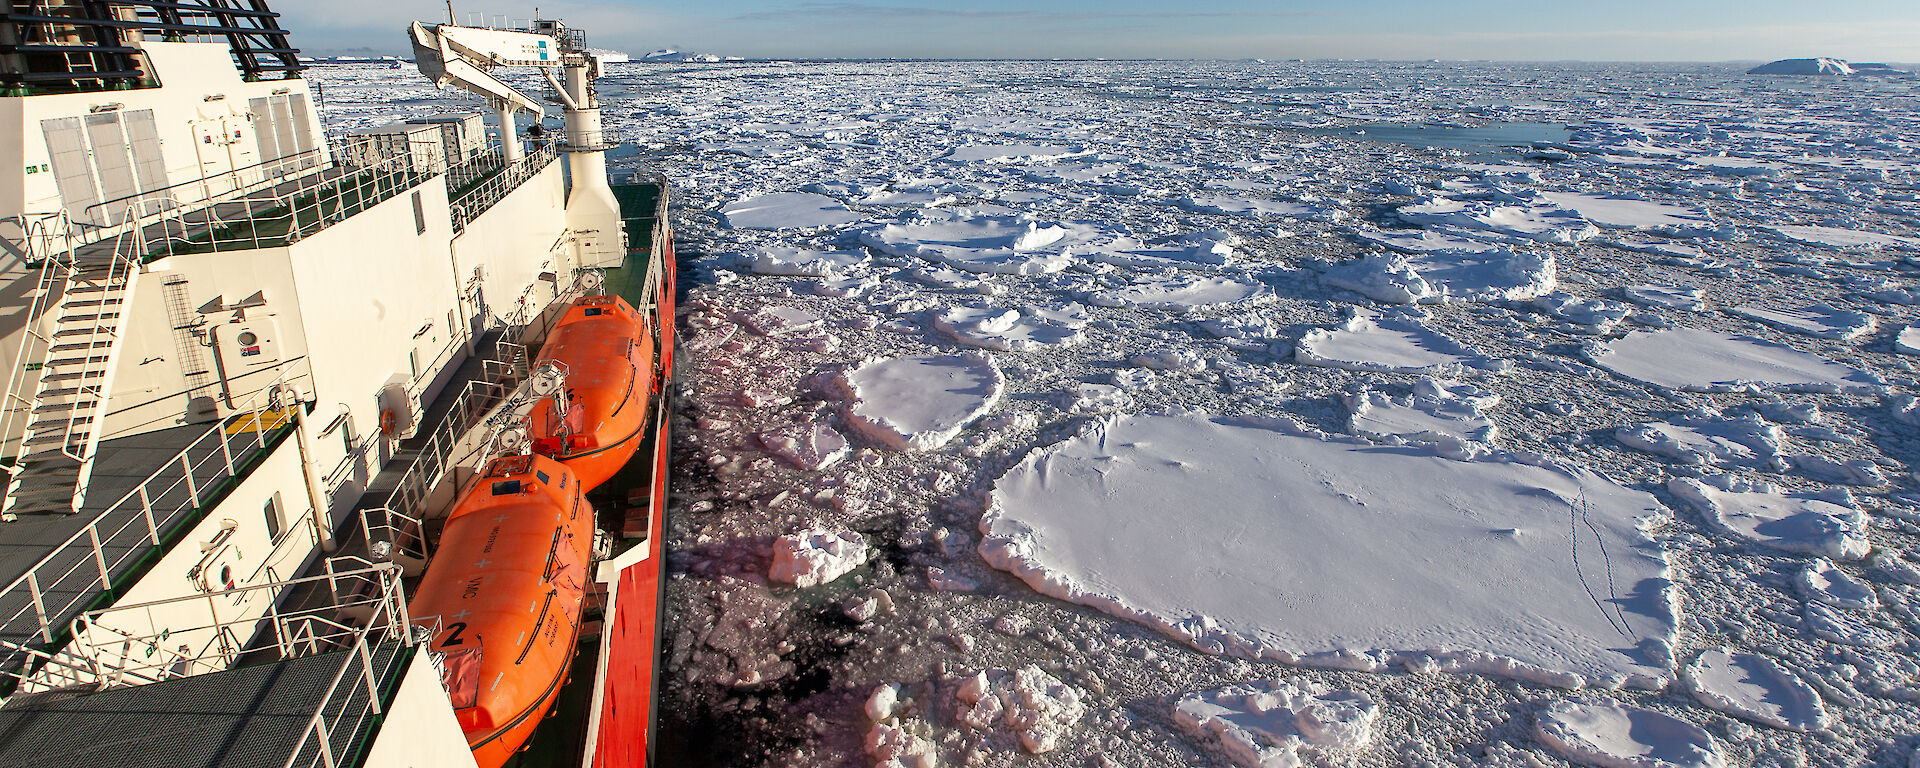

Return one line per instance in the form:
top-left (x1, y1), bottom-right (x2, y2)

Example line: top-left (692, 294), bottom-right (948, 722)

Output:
top-left (407, 455), bottom-right (593, 768)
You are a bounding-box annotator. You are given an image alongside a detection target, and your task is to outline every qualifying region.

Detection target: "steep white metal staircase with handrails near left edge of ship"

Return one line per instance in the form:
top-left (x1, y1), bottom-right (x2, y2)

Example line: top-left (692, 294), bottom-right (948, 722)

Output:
top-left (0, 215), bottom-right (140, 518)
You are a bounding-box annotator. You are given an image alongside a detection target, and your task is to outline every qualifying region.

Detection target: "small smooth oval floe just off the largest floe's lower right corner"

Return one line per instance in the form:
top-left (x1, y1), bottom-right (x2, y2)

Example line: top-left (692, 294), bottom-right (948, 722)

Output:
top-left (1686, 649), bottom-right (1826, 732)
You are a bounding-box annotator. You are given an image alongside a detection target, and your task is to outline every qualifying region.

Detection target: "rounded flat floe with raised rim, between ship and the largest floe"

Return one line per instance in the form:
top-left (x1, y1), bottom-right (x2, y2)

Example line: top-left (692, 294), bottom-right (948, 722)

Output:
top-left (833, 353), bottom-right (1006, 451)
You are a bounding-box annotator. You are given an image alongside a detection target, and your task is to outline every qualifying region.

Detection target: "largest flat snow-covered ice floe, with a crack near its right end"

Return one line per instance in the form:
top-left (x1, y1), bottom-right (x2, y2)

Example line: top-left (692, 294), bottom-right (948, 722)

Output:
top-left (979, 413), bottom-right (1676, 687)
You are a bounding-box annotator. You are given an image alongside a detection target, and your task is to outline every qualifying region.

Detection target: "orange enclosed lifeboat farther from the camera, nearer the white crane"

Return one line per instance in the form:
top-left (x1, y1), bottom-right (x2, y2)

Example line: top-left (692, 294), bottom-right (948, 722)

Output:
top-left (532, 296), bottom-right (655, 490)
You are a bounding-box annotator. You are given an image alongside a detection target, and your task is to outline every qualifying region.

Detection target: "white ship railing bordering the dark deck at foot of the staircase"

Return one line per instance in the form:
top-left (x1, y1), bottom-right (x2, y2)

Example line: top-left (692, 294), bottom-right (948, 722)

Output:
top-left (0, 365), bottom-right (309, 676)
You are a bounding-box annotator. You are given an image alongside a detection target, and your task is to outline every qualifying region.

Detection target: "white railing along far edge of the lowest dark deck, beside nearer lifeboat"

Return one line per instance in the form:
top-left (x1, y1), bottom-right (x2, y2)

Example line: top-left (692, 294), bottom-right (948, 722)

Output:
top-left (47, 561), bottom-right (409, 689)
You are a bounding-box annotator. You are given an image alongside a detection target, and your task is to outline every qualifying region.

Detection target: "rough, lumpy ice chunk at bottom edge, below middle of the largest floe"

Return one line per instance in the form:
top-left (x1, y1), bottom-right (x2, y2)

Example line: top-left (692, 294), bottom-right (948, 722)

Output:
top-left (1173, 680), bottom-right (1380, 768)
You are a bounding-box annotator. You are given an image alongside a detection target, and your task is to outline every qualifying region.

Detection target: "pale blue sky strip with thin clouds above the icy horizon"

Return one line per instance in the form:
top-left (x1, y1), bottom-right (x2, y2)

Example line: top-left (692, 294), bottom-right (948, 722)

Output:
top-left (273, 0), bottom-right (1920, 63)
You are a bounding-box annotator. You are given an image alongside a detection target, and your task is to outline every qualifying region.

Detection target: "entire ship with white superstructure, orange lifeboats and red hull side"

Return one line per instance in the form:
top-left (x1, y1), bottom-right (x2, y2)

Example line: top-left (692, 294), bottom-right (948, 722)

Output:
top-left (0, 0), bottom-right (674, 768)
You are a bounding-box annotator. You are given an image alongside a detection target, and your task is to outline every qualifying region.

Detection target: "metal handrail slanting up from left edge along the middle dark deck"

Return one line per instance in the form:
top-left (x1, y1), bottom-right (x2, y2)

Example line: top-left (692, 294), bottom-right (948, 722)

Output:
top-left (0, 363), bottom-right (309, 670)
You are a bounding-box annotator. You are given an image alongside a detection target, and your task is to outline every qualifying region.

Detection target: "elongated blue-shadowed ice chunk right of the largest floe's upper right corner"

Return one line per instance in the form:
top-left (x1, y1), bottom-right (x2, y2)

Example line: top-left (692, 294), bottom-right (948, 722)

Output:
top-left (1667, 476), bottom-right (1868, 561)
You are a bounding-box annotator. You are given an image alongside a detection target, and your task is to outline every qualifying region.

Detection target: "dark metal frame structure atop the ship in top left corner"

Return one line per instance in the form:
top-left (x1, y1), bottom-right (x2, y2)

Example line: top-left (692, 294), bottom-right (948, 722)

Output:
top-left (0, 0), bottom-right (303, 90)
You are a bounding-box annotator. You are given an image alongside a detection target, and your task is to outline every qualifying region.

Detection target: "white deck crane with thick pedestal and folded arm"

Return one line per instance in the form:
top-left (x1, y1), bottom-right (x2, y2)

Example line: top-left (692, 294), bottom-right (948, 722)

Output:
top-left (409, 19), bottom-right (626, 269)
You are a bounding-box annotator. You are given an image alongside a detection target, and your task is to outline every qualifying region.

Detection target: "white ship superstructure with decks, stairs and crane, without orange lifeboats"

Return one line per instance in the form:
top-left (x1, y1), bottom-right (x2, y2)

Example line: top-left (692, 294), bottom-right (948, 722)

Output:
top-left (0, 0), bottom-right (664, 768)
